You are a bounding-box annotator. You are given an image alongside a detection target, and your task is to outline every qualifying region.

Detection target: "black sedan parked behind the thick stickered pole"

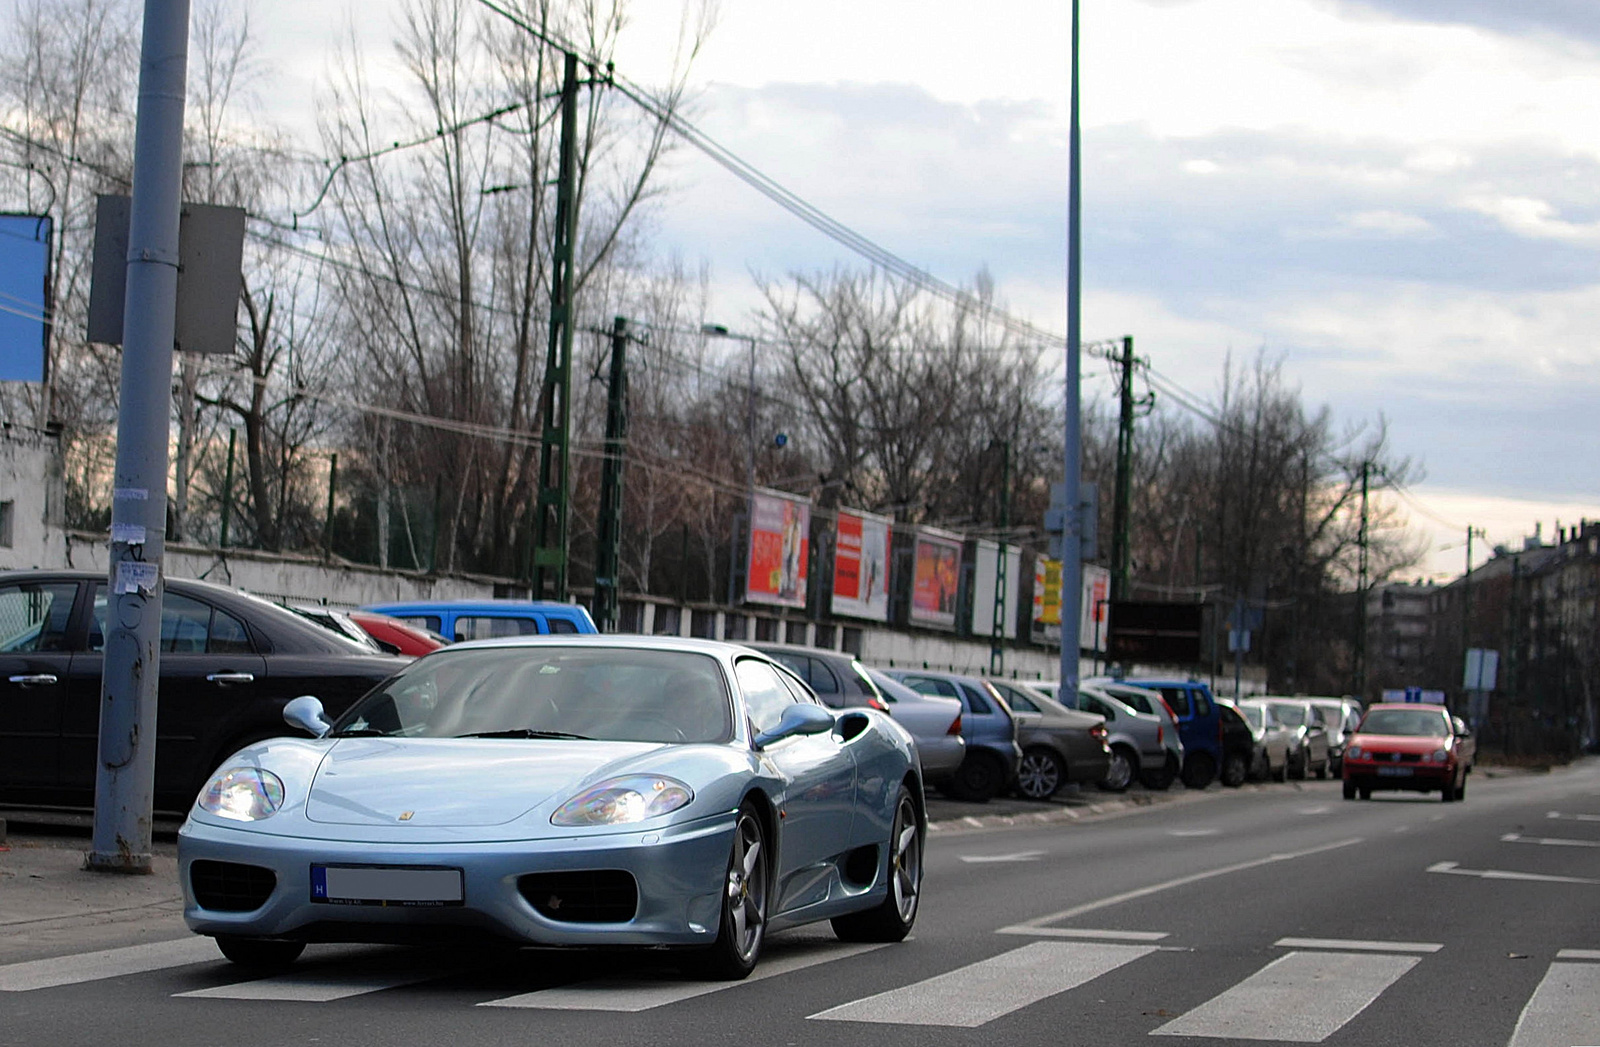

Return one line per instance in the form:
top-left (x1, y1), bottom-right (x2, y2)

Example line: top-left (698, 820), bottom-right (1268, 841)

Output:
top-left (0, 570), bottom-right (406, 813)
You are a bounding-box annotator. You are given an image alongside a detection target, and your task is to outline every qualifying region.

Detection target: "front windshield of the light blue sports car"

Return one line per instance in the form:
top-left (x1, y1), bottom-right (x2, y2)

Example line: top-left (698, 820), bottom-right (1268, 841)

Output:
top-left (337, 645), bottom-right (733, 743)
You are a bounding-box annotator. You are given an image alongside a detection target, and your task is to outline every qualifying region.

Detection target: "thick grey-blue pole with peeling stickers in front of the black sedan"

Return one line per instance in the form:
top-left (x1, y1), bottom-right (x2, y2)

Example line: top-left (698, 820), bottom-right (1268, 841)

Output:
top-left (85, 0), bottom-right (189, 873)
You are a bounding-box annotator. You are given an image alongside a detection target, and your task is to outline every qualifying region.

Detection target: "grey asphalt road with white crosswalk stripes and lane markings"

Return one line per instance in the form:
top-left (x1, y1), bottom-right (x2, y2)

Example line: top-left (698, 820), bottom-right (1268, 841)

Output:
top-left (0, 760), bottom-right (1600, 1047)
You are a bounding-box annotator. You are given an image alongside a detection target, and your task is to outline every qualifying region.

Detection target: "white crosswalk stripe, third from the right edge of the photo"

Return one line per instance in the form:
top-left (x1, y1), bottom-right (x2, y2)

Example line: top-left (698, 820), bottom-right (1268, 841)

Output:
top-left (810, 941), bottom-right (1155, 1029)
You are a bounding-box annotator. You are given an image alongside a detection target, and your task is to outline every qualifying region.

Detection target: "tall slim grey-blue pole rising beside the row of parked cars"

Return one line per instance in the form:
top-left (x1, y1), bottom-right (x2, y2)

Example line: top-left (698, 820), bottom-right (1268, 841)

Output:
top-left (1056, 0), bottom-right (1083, 709)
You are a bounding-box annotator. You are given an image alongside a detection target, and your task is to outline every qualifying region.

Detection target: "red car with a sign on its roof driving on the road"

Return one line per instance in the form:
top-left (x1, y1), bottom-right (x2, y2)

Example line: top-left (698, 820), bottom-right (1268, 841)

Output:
top-left (1344, 704), bottom-right (1477, 804)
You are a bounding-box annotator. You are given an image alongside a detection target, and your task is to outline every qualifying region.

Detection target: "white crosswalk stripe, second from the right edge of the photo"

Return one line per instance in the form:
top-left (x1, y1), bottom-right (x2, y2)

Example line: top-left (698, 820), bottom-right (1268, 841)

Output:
top-left (1150, 953), bottom-right (1421, 1044)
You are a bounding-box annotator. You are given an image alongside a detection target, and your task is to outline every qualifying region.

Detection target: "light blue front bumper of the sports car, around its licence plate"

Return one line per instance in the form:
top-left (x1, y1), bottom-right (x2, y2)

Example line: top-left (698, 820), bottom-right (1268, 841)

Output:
top-left (178, 813), bottom-right (734, 946)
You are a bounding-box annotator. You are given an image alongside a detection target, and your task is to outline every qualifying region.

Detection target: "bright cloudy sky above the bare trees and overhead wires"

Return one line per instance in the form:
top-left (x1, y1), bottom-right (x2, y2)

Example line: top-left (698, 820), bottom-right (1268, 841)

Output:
top-left (254, 0), bottom-right (1600, 575)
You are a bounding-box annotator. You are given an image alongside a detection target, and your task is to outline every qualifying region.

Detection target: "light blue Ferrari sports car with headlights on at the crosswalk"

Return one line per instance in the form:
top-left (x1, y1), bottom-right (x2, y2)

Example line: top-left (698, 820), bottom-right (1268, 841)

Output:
top-left (178, 636), bottom-right (926, 978)
